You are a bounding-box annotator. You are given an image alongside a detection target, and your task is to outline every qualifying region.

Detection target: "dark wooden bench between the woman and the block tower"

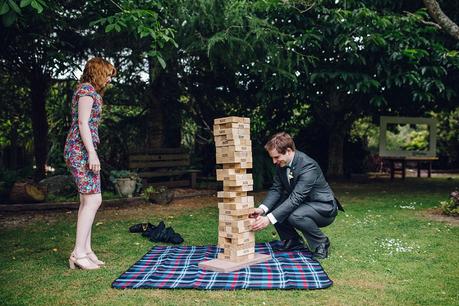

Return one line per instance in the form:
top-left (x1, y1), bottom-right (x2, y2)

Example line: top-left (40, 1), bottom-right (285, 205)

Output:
top-left (129, 148), bottom-right (199, 188)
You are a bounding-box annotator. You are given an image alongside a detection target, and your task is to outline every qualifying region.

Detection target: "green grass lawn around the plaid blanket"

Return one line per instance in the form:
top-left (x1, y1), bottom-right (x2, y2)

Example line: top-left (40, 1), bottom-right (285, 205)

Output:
top-left (0, 178), bottom-right (459, 305)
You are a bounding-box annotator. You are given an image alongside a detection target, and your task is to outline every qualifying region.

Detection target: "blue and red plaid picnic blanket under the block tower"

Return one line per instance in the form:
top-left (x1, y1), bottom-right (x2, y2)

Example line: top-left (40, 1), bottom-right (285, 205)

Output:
top-left (112, 241), bottom-right (333, 290)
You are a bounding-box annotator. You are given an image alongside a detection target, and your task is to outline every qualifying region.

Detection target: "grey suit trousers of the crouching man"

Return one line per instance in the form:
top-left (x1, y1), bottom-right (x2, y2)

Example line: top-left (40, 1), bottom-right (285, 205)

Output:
top-left (274, 203), bottom-right (337, 251)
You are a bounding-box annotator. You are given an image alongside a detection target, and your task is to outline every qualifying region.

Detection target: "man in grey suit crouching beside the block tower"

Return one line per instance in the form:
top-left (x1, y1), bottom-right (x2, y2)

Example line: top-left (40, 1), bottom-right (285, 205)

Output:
top-left (252, 132), bottom-right (344, 259)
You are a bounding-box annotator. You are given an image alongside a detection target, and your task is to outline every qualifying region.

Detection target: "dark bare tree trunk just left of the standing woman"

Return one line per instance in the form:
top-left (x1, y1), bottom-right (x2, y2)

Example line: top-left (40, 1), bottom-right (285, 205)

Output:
top-left (30, 68), bottom-right (51, 180)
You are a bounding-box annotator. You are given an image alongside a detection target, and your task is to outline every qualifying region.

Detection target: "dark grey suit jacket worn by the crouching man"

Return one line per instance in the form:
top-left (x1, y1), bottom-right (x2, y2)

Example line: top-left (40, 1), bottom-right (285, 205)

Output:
top-left (262, 150), bottom-right (337, 222)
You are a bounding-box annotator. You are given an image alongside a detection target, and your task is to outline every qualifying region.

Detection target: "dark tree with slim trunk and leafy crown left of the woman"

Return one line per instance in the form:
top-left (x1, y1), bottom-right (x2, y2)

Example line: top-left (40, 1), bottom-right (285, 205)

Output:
top-left (0, 1), bottom-right (91, 179)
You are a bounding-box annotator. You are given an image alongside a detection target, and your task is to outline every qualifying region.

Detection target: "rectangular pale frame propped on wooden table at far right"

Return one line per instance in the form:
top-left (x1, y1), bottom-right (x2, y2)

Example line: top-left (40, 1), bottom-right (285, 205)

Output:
top-left (379, 116), bottom-right (437, 157)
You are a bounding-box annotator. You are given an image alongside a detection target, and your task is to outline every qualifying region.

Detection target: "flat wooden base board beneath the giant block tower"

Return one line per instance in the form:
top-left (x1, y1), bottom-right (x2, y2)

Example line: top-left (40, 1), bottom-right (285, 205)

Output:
top-left (198, 253), bottom-right (271, 273)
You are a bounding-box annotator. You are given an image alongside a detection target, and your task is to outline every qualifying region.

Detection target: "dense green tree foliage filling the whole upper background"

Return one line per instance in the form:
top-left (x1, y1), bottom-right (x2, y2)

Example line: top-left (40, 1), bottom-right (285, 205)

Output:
top-left (0, 0), bottom-right (459, 178)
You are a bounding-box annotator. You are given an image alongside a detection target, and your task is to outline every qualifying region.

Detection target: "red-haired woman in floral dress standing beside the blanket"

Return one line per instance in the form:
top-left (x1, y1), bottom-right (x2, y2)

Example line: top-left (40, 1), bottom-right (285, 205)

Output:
top-left (64, 57), bottom-right (116, 270)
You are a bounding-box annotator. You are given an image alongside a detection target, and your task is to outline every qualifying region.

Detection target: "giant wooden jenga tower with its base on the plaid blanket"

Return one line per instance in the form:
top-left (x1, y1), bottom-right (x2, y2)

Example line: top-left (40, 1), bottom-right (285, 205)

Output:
top-left (199, 117), bottom-right (271, 272)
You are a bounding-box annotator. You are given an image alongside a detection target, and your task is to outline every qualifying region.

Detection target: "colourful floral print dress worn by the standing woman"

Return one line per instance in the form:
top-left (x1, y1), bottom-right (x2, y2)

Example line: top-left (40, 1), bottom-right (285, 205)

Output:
top-left (64, 83), bottom-right (102, 194)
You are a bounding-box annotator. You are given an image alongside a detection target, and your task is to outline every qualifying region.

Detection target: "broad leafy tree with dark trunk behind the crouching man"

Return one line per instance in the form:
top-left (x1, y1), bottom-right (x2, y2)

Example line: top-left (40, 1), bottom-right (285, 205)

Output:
top-left (206, 1), bottom-right (459, 176)
